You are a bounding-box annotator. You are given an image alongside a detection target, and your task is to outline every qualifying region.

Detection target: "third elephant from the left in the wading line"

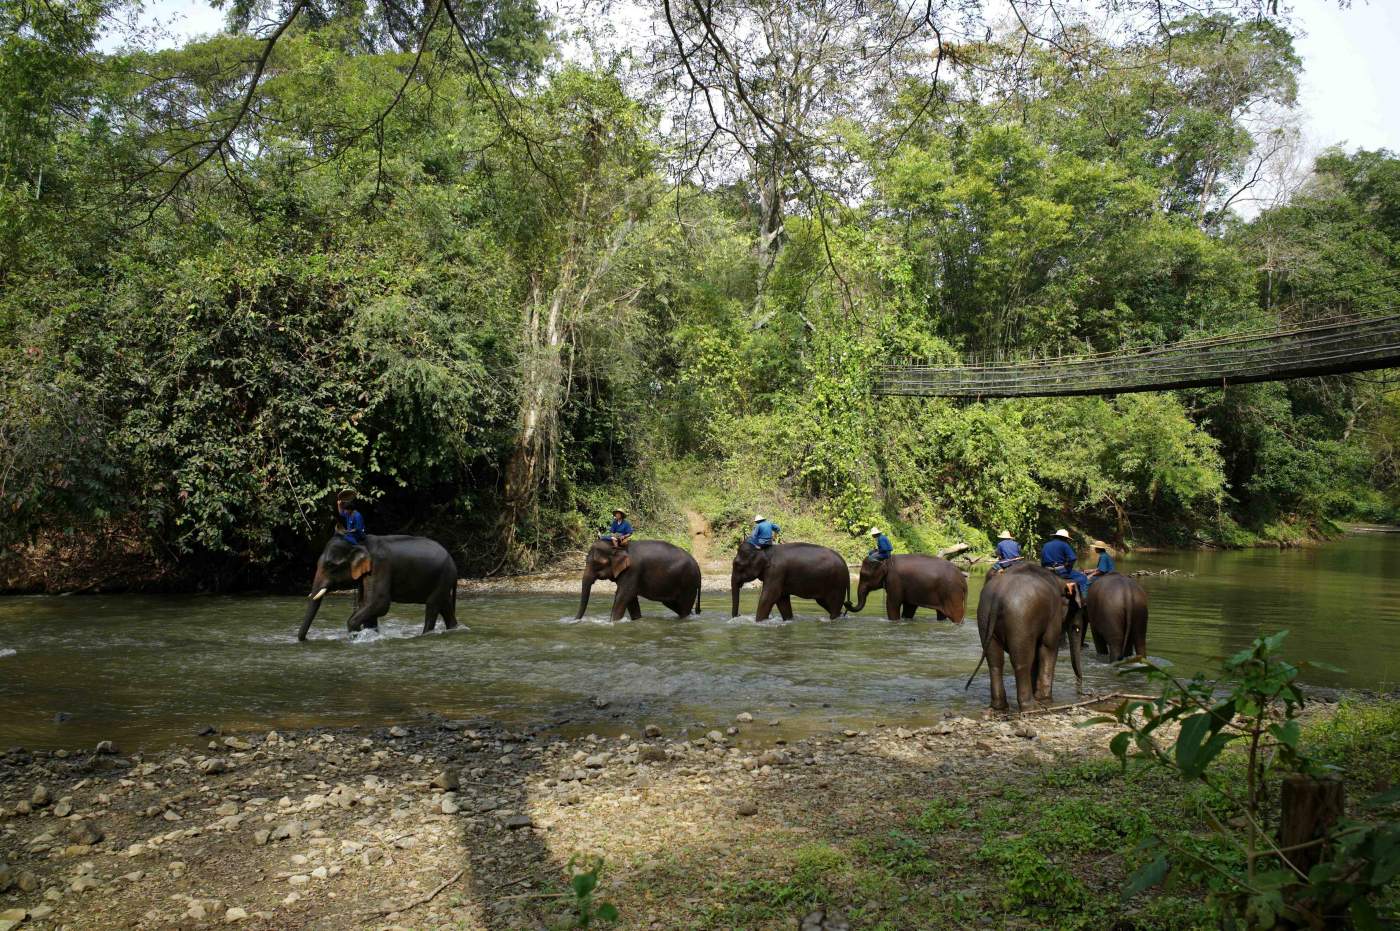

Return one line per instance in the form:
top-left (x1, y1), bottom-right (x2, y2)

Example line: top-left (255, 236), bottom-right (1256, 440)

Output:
top-left (729, 540), bottom-right (851, 620)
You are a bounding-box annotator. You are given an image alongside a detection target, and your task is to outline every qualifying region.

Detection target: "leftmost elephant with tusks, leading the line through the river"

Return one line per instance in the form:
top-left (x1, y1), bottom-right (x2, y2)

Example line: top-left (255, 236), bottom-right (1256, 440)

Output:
top-left (297, 533), bottom-right (456, 640)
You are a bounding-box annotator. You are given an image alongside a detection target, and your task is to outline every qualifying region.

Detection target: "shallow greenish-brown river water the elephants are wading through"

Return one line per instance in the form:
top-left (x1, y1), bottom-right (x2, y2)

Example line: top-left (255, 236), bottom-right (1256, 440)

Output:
top-left (0, 533), bottom-right (1400, 750)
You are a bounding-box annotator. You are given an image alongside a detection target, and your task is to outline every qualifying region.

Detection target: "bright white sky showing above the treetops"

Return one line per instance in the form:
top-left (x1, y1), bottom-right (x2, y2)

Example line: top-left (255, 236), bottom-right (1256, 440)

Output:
top-left (126, 0), bottom-right (1400, 161)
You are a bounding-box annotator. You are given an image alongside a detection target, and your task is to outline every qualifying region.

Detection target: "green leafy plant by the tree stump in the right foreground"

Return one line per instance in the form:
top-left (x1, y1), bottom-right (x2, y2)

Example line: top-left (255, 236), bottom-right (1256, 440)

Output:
top-left (1095, 630), bottom-right (1400, 928)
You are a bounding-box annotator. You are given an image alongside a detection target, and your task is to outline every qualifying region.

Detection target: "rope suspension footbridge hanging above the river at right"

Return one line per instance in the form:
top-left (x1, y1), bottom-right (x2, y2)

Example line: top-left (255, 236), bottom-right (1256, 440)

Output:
top-left (875, 314), bottom-right (1400, 398)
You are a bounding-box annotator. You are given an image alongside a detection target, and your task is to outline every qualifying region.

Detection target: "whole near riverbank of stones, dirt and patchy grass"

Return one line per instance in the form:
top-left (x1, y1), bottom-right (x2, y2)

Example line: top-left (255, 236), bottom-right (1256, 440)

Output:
top-left (0, 706), bottom-right (1394, 931)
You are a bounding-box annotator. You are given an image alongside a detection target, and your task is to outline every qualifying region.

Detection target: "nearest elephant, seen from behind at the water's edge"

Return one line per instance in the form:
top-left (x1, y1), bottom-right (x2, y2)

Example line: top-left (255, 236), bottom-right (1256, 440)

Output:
top-left (974, 564), bottom-right (1084, 711)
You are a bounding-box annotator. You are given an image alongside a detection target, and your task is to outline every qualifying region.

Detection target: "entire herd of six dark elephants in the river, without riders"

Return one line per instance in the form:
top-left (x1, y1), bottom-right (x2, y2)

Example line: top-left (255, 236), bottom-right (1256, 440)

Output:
top-left (297, 535), bottom-right (1147, 710)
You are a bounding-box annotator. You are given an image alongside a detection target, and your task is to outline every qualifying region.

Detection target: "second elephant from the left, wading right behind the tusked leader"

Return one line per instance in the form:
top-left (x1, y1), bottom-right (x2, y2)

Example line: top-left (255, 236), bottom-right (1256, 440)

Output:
top-left (578, 540), bottom-right (700, 620)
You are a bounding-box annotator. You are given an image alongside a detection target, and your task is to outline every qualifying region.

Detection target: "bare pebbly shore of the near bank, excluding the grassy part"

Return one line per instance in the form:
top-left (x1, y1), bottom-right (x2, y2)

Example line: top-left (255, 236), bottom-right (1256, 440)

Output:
top-left (0, 708), bottom-right (1131, 931)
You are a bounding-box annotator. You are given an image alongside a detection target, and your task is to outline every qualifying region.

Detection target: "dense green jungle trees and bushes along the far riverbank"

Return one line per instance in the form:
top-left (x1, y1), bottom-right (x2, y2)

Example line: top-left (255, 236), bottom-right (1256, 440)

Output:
top-left (0, 0), bottom-right (1400, 587)
